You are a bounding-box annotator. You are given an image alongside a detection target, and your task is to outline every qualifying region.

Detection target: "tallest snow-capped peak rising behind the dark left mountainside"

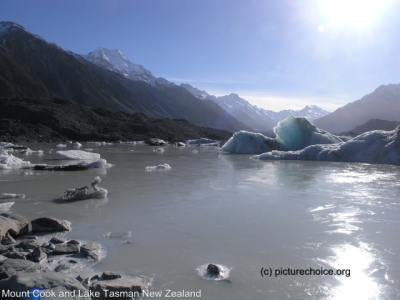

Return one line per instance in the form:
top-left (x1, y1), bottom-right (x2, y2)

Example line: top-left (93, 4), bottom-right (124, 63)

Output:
top-left (83, 47), bottom-right (174, 86)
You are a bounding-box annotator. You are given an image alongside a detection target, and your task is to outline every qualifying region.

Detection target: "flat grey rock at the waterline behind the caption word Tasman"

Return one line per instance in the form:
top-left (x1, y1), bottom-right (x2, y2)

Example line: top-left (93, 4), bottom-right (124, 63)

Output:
top-left (90, 276), bottom-right (151, 299)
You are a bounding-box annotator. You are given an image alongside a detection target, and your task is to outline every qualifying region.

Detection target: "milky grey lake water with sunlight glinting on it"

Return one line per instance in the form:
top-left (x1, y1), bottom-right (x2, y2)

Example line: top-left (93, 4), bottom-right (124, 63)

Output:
top-left (0, 144), bottom-right (400, 300)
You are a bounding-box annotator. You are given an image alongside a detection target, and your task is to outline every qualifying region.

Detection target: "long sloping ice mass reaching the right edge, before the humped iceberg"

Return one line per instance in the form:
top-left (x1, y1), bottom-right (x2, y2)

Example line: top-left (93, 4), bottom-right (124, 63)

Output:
top-left (253, 126), bottom-right (400, 165)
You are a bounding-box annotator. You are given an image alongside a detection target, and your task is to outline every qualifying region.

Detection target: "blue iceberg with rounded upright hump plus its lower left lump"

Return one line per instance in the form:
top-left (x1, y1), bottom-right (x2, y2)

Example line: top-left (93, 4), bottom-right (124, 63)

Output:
top-left (221, 116), bottom-right (342, 154)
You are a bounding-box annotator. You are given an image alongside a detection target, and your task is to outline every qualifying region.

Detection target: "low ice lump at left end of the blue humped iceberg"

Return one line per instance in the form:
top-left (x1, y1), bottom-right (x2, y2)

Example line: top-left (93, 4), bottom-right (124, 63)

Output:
top-left (221, 130), bottom-right (276, 154)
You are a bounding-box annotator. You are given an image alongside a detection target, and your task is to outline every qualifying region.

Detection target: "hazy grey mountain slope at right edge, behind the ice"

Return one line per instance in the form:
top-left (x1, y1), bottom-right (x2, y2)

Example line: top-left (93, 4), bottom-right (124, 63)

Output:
top-left (314, 84), bottom-right (400, 133)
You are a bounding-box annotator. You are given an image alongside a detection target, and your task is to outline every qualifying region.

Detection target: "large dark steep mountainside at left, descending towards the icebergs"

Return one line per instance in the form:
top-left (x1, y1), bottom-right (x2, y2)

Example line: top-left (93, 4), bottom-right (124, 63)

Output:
top-left (0, 22), bottom-right (248, 131)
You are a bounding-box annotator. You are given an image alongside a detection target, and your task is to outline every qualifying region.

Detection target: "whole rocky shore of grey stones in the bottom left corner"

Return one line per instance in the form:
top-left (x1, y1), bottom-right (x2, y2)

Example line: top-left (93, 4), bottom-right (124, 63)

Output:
top-left (0, 212), bottom-right (151, 299)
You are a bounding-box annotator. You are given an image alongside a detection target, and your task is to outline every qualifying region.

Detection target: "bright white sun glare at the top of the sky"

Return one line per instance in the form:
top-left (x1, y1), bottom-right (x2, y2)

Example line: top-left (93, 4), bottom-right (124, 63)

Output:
top-left (320, 0), bottom-right (385, 27)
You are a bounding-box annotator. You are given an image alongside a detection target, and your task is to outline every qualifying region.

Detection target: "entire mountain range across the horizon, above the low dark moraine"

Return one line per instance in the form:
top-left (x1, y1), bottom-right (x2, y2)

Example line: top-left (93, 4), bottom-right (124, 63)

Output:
top-left (0, 22), bottom-right (400, 137)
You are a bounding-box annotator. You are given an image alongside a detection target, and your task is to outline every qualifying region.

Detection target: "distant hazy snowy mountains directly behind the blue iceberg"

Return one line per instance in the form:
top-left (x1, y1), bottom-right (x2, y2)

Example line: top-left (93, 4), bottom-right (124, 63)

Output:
top-left (180, 84), bottom-right (329, 133)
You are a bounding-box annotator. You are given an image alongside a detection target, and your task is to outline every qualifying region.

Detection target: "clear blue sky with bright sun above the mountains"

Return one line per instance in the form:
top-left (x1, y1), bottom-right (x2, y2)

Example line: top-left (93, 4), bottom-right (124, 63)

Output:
top-left (0, 0), bottom-right (400, 111)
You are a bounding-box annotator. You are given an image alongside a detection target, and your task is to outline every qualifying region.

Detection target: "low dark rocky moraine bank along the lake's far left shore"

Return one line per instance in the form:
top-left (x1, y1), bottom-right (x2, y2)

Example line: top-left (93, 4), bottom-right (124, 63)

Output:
top-left (0, 98), bottom-right (232, 142)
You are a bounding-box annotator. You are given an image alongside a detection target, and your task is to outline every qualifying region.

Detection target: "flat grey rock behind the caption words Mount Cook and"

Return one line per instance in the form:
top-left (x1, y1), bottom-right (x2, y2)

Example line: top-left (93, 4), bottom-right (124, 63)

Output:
top-left (3, 272), bottom-right (91, 300)
